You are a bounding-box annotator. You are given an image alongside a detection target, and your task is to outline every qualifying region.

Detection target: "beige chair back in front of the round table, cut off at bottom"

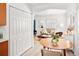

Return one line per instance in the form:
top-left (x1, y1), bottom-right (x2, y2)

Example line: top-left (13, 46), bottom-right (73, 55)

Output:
top-left (41, 49), bottom-right (63, 56)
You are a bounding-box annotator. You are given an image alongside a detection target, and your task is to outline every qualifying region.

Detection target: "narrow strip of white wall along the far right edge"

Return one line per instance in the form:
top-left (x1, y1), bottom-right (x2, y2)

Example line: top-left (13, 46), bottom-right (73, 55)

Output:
top-left (74, 10), bottom-right (79, 56)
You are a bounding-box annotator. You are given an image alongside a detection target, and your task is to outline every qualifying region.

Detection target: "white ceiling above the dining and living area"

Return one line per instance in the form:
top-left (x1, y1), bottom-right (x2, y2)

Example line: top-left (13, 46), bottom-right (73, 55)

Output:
top-left (26, 3), bottom-right (79, 13)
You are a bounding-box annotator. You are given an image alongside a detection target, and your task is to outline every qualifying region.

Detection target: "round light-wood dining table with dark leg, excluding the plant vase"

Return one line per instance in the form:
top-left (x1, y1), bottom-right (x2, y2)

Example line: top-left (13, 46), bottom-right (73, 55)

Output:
top-left (40, 38), bottom-right (71, 56)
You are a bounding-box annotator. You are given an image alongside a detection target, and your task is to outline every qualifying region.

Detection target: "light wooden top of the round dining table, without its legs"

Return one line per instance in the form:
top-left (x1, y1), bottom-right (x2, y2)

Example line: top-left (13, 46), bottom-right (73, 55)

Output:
top-left (40, 38), bottom-right (71, 49)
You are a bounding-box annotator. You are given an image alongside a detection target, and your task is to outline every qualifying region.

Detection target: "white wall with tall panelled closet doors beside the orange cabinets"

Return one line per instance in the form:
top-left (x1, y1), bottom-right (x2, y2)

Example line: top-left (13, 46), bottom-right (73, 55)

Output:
top-left (9, 3), bottom-right (33, 56)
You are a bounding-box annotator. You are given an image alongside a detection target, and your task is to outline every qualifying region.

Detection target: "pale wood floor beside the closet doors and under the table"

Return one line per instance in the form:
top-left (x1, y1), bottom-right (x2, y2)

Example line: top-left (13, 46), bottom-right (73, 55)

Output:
top-left (23, 39), bottom-right (74, 56)
